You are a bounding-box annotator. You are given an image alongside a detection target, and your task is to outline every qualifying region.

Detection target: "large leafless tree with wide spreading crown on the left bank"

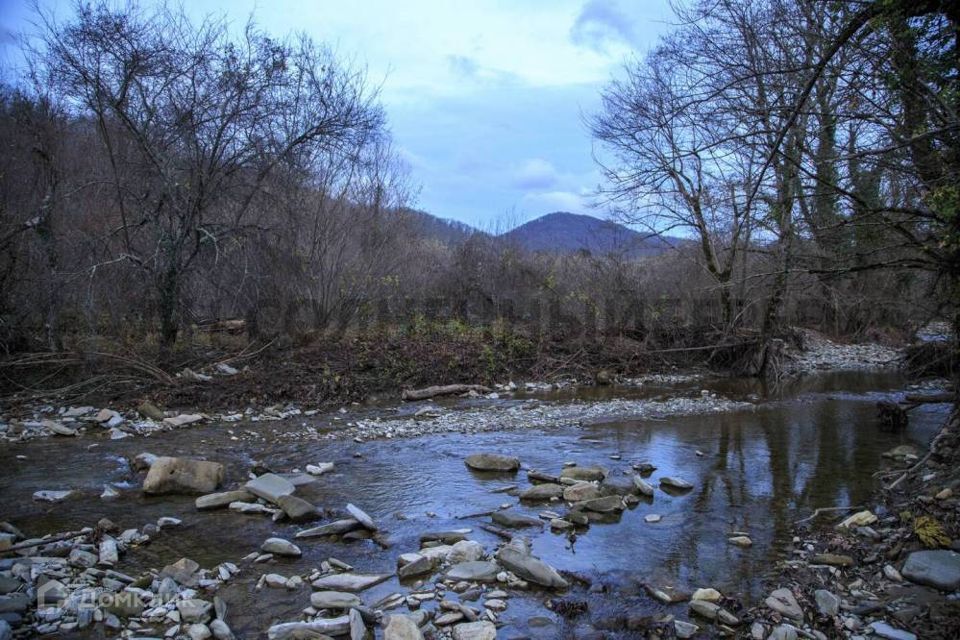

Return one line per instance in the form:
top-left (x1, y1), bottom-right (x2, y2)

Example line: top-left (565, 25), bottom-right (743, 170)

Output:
top-left (34, 2), bottom-right (383, 359)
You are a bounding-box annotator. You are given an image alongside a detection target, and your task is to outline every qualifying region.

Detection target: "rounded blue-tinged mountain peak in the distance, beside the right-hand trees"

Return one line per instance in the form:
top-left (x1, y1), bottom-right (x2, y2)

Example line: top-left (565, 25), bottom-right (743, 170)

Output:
top-left (500, 211), bottom-right (681, 257)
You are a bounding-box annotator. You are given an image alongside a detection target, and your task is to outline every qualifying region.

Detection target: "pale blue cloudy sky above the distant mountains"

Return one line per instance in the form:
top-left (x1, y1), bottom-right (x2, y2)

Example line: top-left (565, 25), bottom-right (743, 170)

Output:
top-left (0, 0), bottom-right (673, 230)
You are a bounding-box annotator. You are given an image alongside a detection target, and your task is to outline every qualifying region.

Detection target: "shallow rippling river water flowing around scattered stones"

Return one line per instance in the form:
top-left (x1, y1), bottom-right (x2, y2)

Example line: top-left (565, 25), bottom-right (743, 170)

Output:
top-left (0, 372), bottom-right (946, 637)
